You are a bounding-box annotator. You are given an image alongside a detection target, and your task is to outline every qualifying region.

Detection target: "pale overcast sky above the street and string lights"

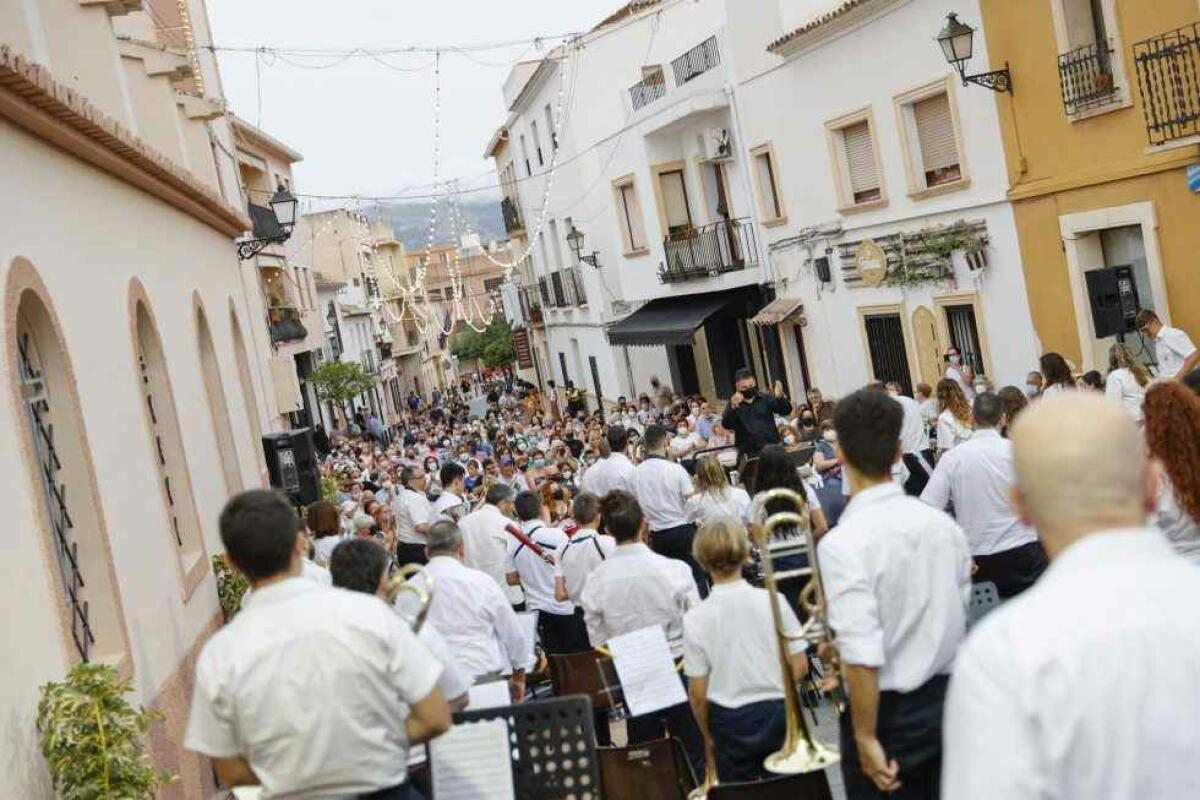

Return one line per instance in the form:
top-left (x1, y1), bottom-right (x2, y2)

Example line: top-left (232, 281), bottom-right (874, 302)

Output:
top-left (208, 0), bottom-right (620, 205)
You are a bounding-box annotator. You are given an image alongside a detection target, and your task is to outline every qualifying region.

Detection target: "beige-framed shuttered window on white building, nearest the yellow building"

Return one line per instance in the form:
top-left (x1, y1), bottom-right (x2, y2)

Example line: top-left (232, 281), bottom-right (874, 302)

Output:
top-left (895, 78), bottom-right (967, 198)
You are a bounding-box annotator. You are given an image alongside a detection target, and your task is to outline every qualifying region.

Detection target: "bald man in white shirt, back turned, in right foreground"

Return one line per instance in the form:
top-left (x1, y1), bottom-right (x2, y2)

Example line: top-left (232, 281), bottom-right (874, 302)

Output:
top-left (942, 392), bottom-right (1200, 800)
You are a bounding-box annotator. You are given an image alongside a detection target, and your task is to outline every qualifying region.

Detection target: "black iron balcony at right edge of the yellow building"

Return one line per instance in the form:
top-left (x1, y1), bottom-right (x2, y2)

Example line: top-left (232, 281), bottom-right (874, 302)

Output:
top-left (1133, 23), bottom-right (1200, 146)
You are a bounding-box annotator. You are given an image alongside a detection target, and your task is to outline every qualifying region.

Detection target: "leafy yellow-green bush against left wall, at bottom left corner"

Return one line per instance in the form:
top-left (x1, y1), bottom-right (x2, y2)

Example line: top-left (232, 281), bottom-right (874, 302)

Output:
top-left (37, 663), bottom-right (175, 800)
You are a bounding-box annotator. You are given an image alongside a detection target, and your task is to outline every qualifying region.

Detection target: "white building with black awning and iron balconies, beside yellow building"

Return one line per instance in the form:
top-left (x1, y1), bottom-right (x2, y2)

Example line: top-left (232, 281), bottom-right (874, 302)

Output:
top-left (487, 0), bottom-right (1038, 399)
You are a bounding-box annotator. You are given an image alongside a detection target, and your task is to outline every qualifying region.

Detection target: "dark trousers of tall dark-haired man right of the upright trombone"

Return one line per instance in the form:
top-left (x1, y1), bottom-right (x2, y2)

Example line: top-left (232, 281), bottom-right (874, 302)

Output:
top-left (840, 675), bottom-right (950, 800)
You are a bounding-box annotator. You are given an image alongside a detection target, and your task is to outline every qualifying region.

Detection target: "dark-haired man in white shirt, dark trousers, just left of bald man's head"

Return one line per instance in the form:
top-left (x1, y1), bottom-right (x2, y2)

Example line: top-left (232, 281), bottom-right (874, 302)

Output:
top-left (920, 392), bottom-right (1046, 599)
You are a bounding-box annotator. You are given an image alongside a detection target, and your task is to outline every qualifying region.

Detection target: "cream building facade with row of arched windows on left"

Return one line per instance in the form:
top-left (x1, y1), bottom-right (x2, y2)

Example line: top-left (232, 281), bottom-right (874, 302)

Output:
top-left (0, 0), bottom-right (280, 798)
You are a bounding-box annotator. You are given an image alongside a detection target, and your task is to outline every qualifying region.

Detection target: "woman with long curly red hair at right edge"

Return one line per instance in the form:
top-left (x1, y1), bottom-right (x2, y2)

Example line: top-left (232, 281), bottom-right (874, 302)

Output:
top-left (1144, 380), bottom-right (1200, 564)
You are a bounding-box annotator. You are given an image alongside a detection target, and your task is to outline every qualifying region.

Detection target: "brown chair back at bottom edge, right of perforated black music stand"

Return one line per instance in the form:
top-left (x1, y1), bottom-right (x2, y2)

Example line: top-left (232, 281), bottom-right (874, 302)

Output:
top-left (596, 738), bottom-right (696, 800)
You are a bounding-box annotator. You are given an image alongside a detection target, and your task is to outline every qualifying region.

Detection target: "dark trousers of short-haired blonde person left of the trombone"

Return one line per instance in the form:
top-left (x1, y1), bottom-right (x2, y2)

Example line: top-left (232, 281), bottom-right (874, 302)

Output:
top-left (708, 700), bottom-right (787, 783)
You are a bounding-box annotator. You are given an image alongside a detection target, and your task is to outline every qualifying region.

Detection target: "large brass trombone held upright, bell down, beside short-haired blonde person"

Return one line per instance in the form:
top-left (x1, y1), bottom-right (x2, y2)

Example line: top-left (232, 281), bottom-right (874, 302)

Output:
top-left (688, 488), bottom-right (842, 800)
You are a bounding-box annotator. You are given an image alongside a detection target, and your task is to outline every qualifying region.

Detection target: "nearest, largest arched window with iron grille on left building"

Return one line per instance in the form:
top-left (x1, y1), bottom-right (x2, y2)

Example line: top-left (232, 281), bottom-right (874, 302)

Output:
top-left (8, 284), bottom-right (128, 664)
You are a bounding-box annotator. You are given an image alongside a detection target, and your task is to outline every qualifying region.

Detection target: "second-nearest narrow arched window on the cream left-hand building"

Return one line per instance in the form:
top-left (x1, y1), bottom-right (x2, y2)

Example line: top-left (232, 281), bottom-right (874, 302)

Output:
top-left (133, 300), bottom-right (208, 599)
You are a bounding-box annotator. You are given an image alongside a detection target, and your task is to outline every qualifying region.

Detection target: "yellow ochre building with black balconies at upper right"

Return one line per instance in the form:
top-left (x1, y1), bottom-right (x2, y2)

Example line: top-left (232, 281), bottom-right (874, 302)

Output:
top-left (967, 0), bottom-right (1200, 371)
